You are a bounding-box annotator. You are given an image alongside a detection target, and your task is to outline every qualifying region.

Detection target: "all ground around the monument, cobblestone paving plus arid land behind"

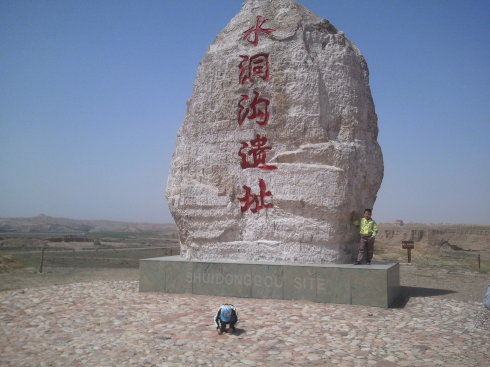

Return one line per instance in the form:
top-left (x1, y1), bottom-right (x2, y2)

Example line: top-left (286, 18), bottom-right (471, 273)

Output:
top-left (0, 216), bottom-right (490, 367)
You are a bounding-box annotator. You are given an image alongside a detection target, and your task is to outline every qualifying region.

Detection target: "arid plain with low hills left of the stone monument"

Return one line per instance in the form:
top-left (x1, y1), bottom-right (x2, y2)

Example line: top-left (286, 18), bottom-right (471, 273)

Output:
top-left (0, 215), bottom-right (179, 290)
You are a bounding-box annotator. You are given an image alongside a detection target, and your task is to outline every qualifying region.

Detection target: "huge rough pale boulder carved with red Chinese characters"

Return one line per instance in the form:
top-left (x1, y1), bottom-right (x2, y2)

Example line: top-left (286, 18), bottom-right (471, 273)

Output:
top-left (166, 0), bottom-right (383, 263)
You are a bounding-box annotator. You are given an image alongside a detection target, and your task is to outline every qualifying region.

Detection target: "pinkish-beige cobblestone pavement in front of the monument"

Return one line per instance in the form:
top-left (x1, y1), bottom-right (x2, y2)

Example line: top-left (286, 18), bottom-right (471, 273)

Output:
top-left (0, 281), bottom-right (490, 367)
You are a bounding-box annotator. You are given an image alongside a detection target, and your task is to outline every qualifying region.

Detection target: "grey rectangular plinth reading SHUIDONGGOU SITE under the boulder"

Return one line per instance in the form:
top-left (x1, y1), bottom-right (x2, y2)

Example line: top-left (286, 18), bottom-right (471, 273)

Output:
top-left (139, 256), bottom-right (400, 307)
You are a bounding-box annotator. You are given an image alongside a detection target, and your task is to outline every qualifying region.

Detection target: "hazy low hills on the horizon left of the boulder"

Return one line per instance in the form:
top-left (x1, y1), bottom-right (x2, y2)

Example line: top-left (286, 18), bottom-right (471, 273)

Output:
top-left (0, 214), bottom-right (177, 233)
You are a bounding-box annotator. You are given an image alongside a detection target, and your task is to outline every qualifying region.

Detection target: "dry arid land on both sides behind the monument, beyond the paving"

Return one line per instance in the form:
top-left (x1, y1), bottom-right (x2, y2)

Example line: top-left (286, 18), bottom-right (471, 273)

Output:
top-left (0, 215), bottom-right (490, 304)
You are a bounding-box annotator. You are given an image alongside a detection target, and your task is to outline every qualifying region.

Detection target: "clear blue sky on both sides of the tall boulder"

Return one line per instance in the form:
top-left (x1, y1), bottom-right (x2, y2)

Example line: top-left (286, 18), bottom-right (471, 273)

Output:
top-left (0, 0), bottom-right (490, 224)
